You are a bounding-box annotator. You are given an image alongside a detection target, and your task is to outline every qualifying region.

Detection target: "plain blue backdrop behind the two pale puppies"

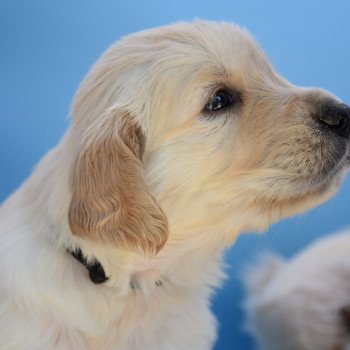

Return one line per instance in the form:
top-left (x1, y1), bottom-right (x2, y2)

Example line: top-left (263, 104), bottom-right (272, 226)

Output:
top-left (0, 0), bottom-right (350, 350)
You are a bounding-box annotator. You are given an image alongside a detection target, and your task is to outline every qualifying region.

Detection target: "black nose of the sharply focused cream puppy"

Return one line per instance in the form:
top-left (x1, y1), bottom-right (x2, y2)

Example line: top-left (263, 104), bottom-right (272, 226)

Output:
top-left (315, 103), bottom-right (350, 139)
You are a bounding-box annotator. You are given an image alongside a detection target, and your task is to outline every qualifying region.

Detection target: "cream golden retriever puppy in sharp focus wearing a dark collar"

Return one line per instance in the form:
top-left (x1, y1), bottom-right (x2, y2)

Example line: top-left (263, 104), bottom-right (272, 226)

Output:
top-left (0, 21), bottom-right (350, 350)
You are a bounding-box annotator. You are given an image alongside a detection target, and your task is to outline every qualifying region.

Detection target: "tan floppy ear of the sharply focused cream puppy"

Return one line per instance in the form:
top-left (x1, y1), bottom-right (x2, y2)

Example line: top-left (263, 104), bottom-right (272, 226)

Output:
top-left (68, 112), bottom-right (168, 254)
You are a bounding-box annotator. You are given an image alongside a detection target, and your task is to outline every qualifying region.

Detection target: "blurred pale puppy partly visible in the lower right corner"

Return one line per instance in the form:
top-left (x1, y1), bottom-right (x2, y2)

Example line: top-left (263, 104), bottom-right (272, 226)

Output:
top-left (245, 232), bottom-right (350, 350)
